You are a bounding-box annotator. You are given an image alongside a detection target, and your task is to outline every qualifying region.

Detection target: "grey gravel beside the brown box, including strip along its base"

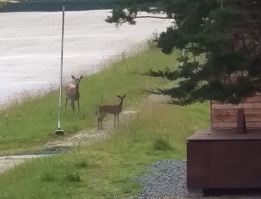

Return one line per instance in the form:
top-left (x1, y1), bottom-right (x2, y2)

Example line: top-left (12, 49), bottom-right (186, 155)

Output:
top-left (131, 159), bottom-right (261, 199)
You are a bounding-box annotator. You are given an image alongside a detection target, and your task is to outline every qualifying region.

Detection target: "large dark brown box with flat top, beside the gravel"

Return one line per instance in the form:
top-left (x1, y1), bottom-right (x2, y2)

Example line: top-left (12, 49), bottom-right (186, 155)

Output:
top-left (187, 129), bottom-right (261, 189)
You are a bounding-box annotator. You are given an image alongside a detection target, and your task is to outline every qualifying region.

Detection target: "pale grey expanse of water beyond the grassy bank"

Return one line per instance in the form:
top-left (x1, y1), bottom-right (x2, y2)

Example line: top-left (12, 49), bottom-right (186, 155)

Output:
top-left (0, 10), bottom-right (170, 104)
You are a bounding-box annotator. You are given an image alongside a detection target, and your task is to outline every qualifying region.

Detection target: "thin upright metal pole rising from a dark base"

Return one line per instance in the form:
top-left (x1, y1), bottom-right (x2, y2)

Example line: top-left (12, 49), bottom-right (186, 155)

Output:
top-left (58, 0), bottom-right (65, 130)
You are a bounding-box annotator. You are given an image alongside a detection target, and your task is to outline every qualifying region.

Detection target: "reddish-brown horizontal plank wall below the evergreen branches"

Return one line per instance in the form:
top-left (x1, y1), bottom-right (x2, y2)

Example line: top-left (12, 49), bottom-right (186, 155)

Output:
top-left (210, 94), bottom-right (261, 129)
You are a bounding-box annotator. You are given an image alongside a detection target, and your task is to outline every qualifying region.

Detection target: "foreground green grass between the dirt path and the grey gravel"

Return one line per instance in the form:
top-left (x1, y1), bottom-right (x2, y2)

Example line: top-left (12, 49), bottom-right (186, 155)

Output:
top-left (0, 103), bottom-right (209, 199)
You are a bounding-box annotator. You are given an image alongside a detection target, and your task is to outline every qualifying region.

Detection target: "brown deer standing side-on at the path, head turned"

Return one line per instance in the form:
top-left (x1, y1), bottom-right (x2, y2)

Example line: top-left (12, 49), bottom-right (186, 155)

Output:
top-left (95, 94), bottom-right (126, 129)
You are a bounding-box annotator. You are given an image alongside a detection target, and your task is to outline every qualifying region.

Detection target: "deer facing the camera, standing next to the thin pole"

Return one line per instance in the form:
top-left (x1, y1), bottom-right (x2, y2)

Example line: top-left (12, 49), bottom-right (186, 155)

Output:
top-left (65, 75), bottom-right (83, 114)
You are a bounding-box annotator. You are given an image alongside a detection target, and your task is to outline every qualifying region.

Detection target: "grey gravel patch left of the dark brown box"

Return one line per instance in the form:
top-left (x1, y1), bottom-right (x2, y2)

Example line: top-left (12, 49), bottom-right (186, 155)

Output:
top-left (132, 160), bottom-right (188, 199)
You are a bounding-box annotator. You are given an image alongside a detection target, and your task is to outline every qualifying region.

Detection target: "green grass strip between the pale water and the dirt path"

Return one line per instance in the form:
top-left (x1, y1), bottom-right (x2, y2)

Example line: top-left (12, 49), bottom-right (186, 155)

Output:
top-left (0, 48), bottom-right (176, 152)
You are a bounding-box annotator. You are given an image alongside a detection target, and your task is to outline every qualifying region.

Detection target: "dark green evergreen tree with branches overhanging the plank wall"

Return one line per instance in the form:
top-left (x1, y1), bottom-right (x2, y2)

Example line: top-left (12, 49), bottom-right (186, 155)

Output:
top-left (106, 0), bottom-right (261, 105)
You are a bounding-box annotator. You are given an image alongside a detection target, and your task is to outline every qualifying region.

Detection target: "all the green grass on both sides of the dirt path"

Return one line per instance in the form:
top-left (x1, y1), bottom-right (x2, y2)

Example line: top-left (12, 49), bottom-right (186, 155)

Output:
top-left (0, 45), bottom-right (209, 199)
